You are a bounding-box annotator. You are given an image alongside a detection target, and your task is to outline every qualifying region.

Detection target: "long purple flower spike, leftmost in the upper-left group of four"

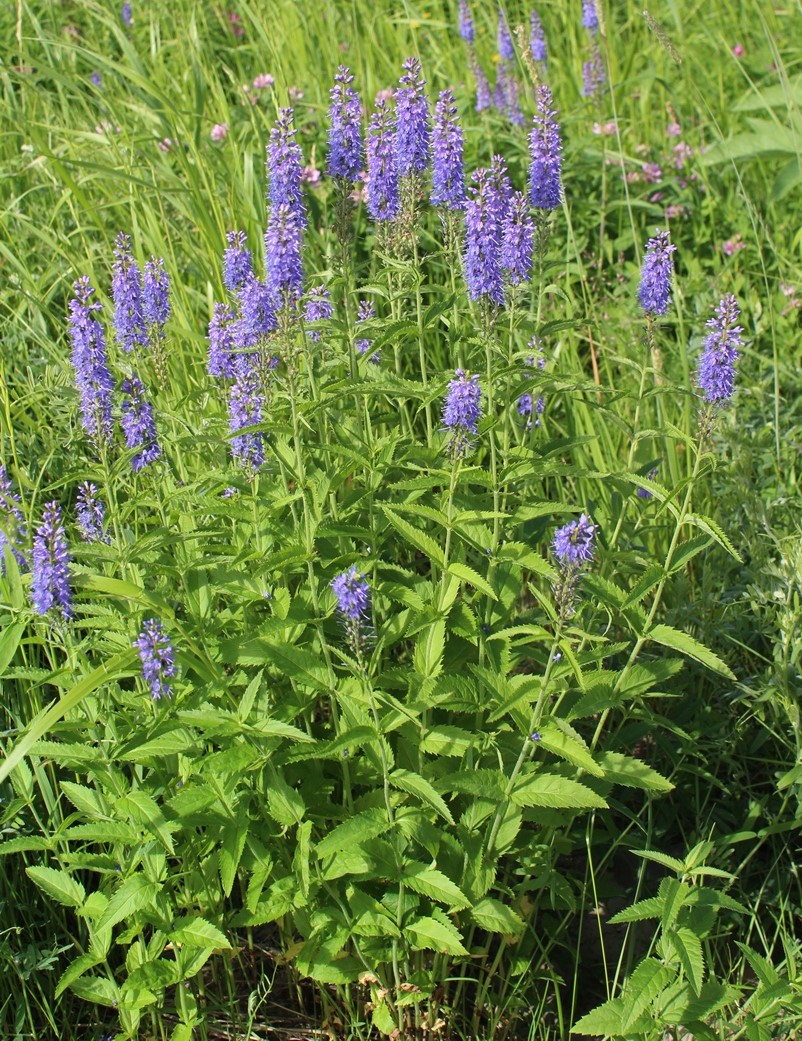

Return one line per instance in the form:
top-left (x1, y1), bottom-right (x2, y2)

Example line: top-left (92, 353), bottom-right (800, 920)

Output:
top-left (69, 276), bottom-right (114, 441)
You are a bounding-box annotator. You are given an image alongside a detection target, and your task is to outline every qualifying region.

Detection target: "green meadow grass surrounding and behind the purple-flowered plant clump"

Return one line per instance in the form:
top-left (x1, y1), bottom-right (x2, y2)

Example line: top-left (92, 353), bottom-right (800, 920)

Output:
top-left (0, 0), bottom-right (802, 1041)
